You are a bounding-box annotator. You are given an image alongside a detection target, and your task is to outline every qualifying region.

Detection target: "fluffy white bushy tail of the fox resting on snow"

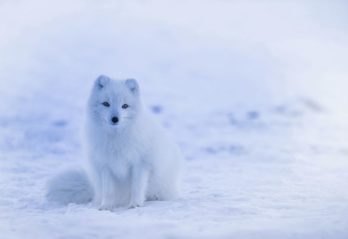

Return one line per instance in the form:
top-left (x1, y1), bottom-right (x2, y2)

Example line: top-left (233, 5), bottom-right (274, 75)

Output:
top-left (46, 170), bottom-right (93, 204)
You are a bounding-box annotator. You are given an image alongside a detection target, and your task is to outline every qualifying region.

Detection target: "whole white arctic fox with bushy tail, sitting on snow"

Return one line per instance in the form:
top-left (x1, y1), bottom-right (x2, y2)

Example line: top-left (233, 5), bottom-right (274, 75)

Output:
top-left (47, 75), bottom-right (183, 210)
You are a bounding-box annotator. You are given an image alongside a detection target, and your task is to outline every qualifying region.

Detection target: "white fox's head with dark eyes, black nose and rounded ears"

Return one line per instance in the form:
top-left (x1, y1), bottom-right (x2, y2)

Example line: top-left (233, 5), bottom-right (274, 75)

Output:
top-left (89, 75), bottom-right (140, 129)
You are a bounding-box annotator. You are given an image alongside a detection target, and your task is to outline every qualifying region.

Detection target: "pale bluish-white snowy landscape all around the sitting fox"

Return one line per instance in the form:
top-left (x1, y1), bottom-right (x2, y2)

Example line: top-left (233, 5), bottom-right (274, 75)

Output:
top-left (0, 0), bottom-right (348, 239)
